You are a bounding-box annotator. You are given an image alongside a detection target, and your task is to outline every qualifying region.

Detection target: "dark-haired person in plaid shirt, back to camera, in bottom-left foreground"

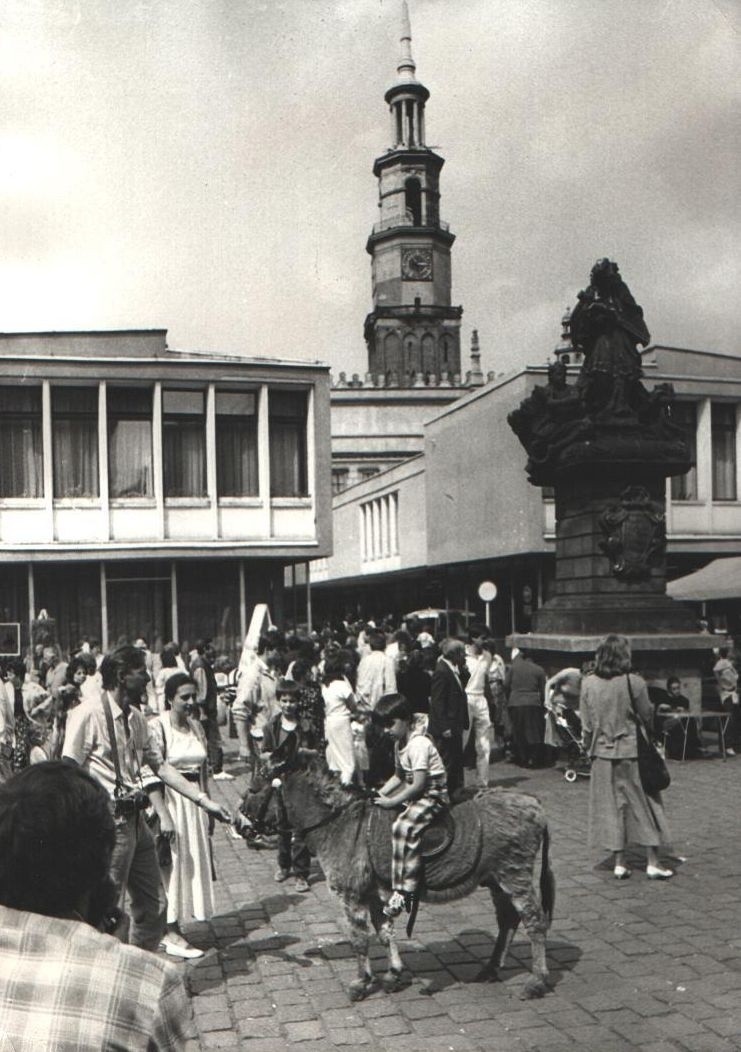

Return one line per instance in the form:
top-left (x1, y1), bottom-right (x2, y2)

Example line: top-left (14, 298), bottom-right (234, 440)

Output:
top-left (0, 762), bottom-right (198, 1052)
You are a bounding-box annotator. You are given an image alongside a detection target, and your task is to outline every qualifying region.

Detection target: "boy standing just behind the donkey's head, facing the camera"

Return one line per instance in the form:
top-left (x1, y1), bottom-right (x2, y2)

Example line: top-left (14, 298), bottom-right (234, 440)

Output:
top-left (262, 680), bottom-right (312, 893)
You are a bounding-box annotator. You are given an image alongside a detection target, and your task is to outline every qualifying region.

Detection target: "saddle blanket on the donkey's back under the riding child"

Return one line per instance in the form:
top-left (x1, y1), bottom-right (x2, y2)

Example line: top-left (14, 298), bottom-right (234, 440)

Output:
top-left (367, 801), bottom-right (481, 891)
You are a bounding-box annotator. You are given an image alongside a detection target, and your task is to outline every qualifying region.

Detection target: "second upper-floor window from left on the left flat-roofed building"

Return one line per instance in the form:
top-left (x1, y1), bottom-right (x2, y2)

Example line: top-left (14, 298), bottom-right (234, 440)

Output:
top-left (52, 387), bottom-right (100, 497)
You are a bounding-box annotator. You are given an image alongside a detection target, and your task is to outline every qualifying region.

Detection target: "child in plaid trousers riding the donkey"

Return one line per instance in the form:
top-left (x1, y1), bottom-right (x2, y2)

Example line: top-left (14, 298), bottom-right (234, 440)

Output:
top-left (374, 694), bottom-right (448, 917)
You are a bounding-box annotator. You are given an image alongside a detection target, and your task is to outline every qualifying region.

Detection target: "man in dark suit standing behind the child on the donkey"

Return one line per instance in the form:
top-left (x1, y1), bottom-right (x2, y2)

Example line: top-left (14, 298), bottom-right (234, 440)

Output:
top-left (428, 639), bottom-right (468, 796)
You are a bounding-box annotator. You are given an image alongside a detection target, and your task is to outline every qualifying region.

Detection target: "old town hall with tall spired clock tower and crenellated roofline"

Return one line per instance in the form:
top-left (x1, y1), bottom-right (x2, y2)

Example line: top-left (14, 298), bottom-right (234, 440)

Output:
top-left (332, 2), bottom-right (484, 493)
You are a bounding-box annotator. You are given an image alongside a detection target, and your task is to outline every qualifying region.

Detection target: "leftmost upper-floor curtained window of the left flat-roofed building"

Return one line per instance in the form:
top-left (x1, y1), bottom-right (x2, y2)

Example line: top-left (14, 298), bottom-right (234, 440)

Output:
top-left (0, 384), bottom-right (44, 498)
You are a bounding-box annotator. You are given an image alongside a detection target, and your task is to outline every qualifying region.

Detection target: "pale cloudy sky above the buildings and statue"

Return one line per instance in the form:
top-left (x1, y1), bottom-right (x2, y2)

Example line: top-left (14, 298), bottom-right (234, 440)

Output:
top-left (0, 0), bottom-right (741, 373)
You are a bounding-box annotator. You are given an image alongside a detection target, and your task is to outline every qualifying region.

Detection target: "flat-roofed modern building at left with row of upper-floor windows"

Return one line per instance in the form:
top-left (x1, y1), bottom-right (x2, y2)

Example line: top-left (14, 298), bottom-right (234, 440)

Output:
top-left (0, 329), bottom-right (332, 650)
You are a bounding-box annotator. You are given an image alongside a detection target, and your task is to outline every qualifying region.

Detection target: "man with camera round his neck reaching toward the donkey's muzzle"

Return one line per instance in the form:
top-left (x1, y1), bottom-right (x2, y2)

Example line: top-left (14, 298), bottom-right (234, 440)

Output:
top-left (62, 644), bottom-right (231, 950)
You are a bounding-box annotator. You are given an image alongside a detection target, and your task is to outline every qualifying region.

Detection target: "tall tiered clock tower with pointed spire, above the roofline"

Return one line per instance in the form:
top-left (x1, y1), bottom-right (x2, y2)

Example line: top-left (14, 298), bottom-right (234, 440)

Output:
top-left (365, 0), bottom-right (463, 387)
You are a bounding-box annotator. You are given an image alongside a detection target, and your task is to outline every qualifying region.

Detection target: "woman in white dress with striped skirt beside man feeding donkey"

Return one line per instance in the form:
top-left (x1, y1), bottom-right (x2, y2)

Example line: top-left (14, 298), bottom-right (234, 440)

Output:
top-left (151, 672), bottom-right (214, 958)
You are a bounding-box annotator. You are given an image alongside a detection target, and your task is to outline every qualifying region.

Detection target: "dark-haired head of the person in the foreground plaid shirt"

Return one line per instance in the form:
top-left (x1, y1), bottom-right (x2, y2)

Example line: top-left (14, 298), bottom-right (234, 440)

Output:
top-left (0, 761), bottom-right (116, 926)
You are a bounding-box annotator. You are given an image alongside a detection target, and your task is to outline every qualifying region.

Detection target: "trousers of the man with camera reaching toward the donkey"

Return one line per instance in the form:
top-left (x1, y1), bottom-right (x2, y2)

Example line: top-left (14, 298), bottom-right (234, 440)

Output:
top-left (111, 814), bottom-right (167, 952)
